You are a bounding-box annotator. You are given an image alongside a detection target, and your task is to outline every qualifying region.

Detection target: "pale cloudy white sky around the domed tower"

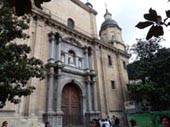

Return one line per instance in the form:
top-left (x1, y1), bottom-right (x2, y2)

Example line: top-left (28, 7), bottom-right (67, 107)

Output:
top-left (81, 0), bottom-right (170, 47)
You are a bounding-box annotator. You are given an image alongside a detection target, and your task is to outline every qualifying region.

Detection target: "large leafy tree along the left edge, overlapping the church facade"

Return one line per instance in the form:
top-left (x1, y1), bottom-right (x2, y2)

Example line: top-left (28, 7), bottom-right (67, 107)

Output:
top-left (0, 3), bottom-right (44, 108)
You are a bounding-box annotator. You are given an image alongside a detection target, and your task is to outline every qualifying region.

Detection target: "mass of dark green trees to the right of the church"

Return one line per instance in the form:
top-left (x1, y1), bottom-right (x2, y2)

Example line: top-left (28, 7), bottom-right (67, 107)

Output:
top-left (128, 39), bottom-right (170, 110)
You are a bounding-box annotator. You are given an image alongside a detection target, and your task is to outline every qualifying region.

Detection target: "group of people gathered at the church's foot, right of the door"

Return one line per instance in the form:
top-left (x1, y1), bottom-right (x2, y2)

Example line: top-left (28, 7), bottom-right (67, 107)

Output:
top-left (90, 116), bottom-right (120, 127)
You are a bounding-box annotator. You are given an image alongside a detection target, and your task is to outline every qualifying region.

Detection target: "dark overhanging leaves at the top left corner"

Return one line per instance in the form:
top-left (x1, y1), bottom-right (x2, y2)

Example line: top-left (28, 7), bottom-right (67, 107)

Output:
top-left (2, 0), bottom-right (51, 16)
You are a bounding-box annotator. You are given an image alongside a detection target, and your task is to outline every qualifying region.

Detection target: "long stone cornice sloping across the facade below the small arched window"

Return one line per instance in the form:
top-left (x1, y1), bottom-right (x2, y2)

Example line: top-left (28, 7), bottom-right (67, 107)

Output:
top-left (32, 8), bottom-right (130, 58)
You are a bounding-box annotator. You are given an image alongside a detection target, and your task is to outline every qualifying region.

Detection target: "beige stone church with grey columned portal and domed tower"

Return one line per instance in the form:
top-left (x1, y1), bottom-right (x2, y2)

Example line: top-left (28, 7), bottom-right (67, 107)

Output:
top-left (0, 0), bottom-right (129, 127)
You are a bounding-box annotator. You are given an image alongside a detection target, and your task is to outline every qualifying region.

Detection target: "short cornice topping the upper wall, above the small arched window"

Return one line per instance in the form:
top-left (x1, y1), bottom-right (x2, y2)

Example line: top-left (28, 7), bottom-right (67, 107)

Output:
top-left (71, 0), bottom-right (97, 15)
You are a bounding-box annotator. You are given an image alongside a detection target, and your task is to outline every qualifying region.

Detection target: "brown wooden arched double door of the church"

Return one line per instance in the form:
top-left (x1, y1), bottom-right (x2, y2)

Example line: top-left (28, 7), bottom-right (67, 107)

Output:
top-left (62, 83), bottom-right (82, 127)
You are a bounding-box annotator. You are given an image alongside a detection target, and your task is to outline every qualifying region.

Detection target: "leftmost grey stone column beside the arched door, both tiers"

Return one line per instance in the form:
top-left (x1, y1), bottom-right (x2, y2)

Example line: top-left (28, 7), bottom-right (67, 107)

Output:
top-left (44, 32), bottom-right (56, 127)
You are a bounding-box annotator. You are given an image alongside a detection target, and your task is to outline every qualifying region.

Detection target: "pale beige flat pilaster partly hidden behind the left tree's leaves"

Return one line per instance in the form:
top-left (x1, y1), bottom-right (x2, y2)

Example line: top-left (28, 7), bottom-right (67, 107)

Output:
top-left (26, 17), bottom-right (44, 117)
